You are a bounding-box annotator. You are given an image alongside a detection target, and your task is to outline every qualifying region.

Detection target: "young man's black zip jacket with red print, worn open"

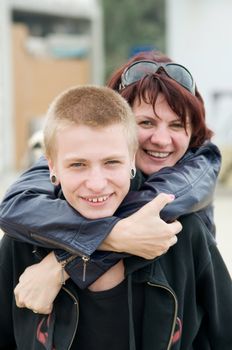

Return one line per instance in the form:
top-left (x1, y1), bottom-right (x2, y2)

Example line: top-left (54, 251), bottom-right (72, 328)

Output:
top-left (0, 214), bottom-right (232, 350)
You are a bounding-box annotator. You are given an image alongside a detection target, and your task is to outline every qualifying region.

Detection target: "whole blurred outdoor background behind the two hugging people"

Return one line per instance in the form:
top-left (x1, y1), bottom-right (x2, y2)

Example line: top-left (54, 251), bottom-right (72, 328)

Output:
top-left (0, 0), bottom-right (232, 272)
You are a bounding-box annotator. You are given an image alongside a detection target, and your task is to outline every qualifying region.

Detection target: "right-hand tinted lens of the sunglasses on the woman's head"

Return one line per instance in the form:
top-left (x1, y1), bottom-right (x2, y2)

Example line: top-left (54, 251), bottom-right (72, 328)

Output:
top-left (165, 64), bottom-right (194, 93)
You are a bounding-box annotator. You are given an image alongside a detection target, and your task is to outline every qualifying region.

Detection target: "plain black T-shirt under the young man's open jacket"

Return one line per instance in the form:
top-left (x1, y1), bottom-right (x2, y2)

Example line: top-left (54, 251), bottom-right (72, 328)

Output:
top-left (71, 280), bottom-right (143, 350)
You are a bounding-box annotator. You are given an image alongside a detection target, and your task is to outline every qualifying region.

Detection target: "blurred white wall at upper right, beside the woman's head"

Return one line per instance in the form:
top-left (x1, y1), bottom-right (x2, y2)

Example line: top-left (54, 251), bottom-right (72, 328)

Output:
top-left (166, 0), bottom-right (232, 144)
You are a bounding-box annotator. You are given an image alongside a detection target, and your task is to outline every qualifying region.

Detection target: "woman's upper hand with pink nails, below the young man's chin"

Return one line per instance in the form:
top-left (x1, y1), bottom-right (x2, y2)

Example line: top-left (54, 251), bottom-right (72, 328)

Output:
top-left (100, 193), bottom-right (182, 259)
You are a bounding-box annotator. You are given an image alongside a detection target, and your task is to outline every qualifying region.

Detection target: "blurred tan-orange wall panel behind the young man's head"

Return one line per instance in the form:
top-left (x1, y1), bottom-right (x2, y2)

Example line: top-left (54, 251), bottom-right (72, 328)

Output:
top-left (12, 24), bottom-right (90, 169)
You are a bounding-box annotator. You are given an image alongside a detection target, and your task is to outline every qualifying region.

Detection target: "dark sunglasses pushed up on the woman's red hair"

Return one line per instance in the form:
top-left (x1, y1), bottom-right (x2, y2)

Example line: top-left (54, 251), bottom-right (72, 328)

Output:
top-left (119, 60), bottom-right (195, 95)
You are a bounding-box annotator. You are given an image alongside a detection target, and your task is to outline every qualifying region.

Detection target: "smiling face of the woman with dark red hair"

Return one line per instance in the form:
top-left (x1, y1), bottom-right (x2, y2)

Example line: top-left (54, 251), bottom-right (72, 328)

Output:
top-left (132, 94), bottom-right (191, 175)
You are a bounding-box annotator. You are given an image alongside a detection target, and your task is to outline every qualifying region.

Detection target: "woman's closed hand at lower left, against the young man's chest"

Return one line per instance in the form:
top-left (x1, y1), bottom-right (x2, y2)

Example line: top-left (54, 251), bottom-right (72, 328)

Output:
top-left (14, 252), bottom-right (69, 314)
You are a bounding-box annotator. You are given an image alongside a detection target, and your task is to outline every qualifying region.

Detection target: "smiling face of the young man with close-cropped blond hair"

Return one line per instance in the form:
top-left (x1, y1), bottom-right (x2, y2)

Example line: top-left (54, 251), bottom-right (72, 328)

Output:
top-left (49, 125), bottom-right (133, 219)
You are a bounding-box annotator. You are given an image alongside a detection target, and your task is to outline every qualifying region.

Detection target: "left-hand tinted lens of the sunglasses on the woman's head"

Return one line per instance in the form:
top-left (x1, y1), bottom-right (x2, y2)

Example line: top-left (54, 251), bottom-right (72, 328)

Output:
top-left (123, 62), bottom-right (158, 86)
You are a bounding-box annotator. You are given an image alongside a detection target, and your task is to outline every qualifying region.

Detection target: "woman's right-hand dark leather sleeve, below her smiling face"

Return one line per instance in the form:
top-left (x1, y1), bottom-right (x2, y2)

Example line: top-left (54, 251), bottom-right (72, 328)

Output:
top-left (116, 142), bottom-right (221, 221)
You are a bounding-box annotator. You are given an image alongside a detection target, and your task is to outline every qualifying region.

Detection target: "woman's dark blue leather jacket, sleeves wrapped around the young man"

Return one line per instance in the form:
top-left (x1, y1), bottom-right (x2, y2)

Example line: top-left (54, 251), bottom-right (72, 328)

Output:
top-left (0, 142), bottom-right (221, 288)
